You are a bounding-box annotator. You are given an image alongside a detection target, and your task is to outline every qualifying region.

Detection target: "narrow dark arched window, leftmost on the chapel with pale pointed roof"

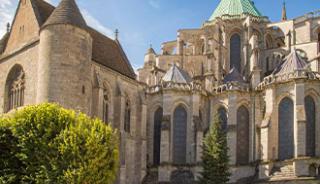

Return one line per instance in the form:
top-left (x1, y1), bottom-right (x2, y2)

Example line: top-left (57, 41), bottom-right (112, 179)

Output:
top-left (153, 107), bottom-right (163, 166)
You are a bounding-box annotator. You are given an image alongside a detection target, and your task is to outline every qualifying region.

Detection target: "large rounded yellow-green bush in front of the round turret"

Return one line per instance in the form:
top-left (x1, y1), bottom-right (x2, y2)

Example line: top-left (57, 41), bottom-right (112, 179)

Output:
top-left (0, 104), bottom-right (119, 184)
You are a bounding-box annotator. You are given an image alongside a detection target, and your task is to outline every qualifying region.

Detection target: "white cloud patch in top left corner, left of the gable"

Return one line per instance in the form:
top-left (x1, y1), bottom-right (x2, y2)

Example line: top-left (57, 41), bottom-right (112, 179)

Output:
top-left (0, 0), bottom-right (15, 38)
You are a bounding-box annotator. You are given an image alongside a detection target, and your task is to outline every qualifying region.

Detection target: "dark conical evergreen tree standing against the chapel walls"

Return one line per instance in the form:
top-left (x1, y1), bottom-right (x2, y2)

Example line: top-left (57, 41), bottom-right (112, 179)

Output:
top-left (199, 115), bottom-right (231, 184)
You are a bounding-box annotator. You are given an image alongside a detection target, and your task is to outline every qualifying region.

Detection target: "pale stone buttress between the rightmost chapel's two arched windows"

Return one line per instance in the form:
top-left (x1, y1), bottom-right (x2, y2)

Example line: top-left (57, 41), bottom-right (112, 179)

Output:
top-left (294, 83), bottom-right (306, 158)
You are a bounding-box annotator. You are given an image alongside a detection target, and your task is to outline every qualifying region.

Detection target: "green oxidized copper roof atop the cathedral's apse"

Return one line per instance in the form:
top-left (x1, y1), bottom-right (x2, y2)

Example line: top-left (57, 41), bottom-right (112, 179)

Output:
top-left (209, 0), bottom-right (262, 21)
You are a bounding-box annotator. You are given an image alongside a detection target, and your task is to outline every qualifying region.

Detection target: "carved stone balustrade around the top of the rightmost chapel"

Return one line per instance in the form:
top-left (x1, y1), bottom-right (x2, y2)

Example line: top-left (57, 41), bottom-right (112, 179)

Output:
top-left (256, 70), bottom-right (320, 91)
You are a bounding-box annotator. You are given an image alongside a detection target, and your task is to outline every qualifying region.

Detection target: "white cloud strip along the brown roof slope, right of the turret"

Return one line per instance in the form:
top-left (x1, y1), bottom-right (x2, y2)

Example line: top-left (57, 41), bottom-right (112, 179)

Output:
top-left (81, 9), bottom-right (114, 38)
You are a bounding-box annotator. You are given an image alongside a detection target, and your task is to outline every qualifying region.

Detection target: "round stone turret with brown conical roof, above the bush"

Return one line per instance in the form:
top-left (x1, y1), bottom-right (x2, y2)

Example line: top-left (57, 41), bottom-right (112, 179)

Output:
top-left (37, 0), bottom-right (92, 114)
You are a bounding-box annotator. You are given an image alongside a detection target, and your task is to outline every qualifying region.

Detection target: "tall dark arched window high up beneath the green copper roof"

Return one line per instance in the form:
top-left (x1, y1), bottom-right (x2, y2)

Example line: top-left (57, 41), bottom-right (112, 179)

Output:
top-left (230, 34), bottom-right (241, 72)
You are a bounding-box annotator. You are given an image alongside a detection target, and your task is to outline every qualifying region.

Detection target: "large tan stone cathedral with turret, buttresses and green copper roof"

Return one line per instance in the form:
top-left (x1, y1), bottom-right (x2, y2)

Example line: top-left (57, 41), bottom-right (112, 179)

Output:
top-left (0, 0), bottom-right (320, 184)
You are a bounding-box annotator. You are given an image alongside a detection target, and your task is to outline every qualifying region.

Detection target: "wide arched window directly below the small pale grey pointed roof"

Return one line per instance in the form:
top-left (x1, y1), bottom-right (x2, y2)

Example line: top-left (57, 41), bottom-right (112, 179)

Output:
top-left (173, 105), bottom-right (188, 165)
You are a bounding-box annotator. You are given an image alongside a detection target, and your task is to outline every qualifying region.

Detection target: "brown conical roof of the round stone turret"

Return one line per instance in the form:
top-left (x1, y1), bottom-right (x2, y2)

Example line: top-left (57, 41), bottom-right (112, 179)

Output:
top-left (42, 0), bottom-right (87, 28)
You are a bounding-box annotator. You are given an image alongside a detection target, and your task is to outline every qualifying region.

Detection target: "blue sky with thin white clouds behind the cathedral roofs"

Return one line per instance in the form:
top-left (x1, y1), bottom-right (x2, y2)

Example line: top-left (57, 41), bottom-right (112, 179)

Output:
top-left (0, 0), bottom-right (320, 69)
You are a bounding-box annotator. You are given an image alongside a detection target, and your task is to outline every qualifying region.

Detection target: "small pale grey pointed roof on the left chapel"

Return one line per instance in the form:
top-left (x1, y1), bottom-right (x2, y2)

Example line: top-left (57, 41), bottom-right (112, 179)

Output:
top-left (162, 64), bottom-right (192, 84)
